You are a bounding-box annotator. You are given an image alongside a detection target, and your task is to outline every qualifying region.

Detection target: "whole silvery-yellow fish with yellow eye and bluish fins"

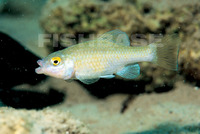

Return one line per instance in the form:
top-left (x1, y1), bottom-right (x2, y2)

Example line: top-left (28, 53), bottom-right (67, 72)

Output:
top-left (35, 29), bottom-right (180, 84)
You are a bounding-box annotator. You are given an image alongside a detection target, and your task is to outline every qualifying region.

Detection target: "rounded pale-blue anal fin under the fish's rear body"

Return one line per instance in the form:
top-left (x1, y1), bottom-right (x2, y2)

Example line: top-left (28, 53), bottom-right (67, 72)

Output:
top-left (116, 64), bottom-right (140, 79)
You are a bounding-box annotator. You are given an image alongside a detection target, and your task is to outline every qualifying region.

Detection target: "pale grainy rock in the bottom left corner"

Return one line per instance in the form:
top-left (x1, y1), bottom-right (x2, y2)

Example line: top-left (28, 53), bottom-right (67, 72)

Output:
top-left (0, 107), bottom-right (90, 134)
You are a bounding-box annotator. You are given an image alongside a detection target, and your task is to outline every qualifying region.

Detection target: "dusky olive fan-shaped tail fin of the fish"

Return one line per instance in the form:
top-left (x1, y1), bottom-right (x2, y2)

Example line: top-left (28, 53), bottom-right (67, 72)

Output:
top-left (151, 34), bottom-right (180, 71)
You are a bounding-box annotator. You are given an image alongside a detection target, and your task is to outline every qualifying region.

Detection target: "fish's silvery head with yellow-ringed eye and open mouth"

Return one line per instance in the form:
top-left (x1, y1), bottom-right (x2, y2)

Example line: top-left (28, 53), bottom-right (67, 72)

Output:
top-left (35, 52), bottom-right (74, 80)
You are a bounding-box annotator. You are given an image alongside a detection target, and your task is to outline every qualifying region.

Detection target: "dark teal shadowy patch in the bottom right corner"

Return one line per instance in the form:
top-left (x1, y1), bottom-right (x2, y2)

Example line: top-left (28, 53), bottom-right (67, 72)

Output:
top-left (124, 123), bottom-right (200, 134)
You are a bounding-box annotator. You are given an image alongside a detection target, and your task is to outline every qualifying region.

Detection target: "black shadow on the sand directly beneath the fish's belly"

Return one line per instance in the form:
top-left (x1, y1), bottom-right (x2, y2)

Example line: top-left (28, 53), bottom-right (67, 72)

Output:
top-left (79, 79), bottom-right (172, 98)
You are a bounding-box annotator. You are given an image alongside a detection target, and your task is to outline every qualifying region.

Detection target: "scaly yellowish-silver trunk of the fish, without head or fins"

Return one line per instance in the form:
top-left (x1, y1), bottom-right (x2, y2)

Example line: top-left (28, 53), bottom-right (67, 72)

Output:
top-left (67, 41), bottom-right (151, 78)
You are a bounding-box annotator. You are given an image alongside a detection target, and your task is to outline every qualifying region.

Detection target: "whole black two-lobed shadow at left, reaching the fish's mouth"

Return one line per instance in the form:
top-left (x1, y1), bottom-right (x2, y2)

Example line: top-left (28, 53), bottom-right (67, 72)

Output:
top-left (0, 32), bottom-right (65, 109)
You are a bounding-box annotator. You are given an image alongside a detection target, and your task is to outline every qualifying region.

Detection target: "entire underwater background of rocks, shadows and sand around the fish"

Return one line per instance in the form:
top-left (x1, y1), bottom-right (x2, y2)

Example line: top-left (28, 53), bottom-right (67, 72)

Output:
top-left (0, 0), bottom-right (200, 134)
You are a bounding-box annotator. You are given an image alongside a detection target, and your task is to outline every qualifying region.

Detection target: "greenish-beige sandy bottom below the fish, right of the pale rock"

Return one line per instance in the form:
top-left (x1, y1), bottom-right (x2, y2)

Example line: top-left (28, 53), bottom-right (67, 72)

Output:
top-left (13, 78), bottom-right (200, 134)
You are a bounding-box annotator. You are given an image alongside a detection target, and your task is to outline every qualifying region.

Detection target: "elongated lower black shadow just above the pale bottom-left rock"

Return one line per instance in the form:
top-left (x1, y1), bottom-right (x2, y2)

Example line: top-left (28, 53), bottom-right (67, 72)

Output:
top-left (0, 89), bottom-right (65, 109)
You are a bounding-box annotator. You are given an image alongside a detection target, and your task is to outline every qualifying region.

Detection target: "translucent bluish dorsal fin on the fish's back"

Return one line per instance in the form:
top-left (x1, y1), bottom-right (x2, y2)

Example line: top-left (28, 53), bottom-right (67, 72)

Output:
top-left (97, 29), bottom-right (130, 46)
